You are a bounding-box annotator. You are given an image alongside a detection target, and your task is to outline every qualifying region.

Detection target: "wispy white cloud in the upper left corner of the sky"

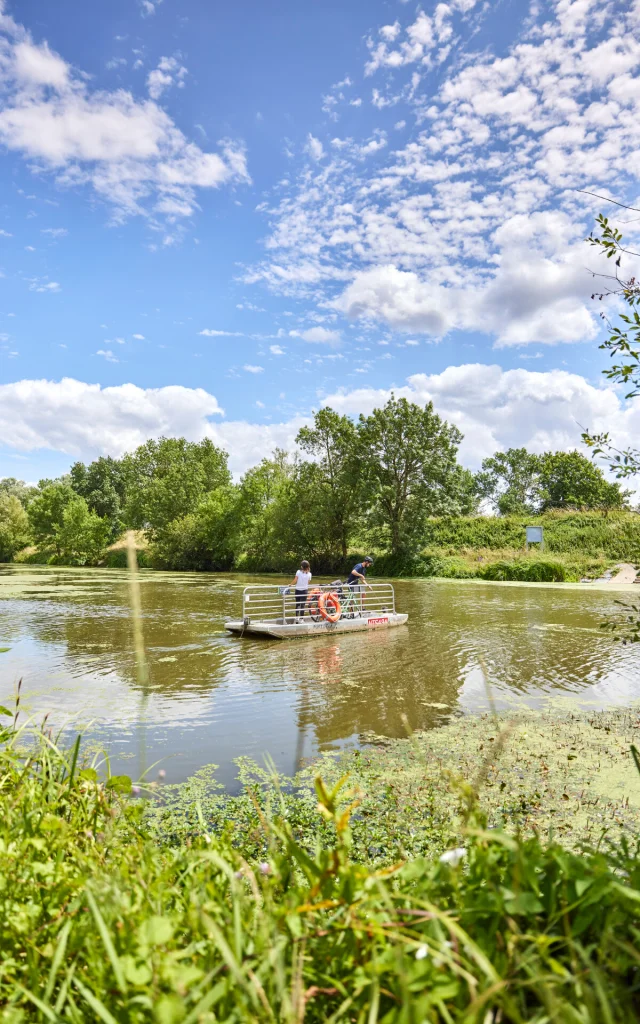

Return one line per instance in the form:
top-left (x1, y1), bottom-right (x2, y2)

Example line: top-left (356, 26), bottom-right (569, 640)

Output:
top-left (0, 16), bottom-right (250, 225)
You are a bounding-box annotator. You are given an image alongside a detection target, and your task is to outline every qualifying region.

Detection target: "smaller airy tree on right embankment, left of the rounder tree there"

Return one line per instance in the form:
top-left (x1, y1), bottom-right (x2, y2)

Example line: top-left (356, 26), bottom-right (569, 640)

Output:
top-left (476, 447), bottom-right (540, 515)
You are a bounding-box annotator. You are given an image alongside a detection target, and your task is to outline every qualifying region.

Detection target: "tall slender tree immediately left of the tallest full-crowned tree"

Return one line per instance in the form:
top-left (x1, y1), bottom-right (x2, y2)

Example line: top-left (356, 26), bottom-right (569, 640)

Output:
top-left (296, 409), bottom-right (360, 559)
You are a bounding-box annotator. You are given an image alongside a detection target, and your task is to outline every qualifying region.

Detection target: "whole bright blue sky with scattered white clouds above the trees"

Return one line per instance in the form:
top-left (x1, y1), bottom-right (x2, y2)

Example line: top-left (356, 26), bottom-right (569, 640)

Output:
top-left (0, 0), bottom-right (640, 480)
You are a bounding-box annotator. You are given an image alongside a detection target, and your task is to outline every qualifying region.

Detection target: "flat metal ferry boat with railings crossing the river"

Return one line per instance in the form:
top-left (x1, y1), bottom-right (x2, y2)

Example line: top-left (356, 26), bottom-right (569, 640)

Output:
top-left (224, 580), bottom-right (409, 640)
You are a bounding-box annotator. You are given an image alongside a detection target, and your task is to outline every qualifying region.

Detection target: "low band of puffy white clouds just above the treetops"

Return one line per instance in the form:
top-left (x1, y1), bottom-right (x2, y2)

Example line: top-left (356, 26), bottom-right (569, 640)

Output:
top-left (0, 364), bottom-right (640, 485)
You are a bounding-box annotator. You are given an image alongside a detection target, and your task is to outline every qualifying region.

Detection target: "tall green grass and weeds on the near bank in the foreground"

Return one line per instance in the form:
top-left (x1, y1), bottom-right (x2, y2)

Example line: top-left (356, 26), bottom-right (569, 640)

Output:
top-left (0, 704), bottom-right (640, 1024)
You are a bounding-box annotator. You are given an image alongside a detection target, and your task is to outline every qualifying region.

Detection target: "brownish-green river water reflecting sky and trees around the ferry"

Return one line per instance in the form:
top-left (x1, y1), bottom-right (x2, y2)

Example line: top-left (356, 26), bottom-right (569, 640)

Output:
top-left (0, 565), bottom-right (640, 788)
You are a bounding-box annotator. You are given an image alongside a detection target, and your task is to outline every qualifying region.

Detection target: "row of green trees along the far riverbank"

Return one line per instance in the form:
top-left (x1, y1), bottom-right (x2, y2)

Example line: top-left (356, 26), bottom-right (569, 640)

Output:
top-left (0, 396), bottom-right (629, 571)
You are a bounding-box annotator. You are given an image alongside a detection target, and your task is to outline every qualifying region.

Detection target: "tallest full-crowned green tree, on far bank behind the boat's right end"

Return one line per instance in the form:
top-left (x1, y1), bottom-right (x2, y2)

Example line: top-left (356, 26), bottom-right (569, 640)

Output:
top-left (358, 396), bottom-right (462, 554)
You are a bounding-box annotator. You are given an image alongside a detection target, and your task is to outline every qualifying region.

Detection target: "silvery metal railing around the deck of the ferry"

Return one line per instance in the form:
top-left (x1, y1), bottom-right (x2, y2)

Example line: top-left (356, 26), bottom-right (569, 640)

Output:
top-left (243, 581), bottom-right (395, 625)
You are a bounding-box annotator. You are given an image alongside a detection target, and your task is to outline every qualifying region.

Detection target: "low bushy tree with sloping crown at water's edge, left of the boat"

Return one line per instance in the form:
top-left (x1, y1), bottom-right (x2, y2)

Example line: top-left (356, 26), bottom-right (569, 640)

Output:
top-left (150, 485), bottom-right (239, 572)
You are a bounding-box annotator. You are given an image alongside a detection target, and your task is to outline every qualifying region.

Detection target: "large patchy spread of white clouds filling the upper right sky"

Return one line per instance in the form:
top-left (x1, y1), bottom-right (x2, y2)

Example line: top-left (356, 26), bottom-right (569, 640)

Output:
top-left (246, 0), bottom-right (640, 347)
